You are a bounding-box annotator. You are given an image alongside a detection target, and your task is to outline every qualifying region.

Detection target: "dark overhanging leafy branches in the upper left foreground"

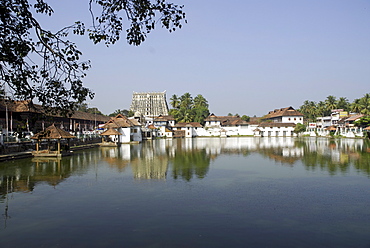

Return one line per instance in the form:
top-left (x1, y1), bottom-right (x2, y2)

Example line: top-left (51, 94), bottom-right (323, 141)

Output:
top-left (0, 0), bottom-right (186, 114)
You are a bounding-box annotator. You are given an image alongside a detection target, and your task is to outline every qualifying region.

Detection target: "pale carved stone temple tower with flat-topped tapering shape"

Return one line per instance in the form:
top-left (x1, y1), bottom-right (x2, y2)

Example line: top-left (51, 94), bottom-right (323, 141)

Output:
top-left (130, 91), bottom-right (168, 117)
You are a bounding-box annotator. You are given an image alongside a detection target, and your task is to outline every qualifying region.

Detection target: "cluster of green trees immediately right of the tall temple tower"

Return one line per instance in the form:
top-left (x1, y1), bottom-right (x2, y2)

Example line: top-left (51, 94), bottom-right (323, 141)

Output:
top-left (169, 93), bottom-right (209, 123)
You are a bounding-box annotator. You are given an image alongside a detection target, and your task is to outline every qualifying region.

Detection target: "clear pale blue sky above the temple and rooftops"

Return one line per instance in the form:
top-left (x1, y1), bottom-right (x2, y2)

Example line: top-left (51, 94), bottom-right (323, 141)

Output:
top-left (34, 0), bottom-right (370, 116)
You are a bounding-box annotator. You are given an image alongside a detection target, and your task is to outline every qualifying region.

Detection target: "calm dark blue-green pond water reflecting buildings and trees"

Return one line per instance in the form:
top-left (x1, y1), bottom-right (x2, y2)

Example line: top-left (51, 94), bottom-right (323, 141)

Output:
top-left (0, 137), bottom-right (370, 248)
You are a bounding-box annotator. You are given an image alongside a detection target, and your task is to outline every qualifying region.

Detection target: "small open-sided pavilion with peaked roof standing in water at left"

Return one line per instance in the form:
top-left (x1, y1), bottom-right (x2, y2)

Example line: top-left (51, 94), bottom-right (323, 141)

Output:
top-left (32, 124), bottom-right (75, 157)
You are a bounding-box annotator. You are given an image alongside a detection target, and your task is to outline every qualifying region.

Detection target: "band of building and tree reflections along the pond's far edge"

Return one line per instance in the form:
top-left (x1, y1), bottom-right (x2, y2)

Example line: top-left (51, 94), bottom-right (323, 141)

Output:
top-left (0, 138), bottom-right (370, 198)
